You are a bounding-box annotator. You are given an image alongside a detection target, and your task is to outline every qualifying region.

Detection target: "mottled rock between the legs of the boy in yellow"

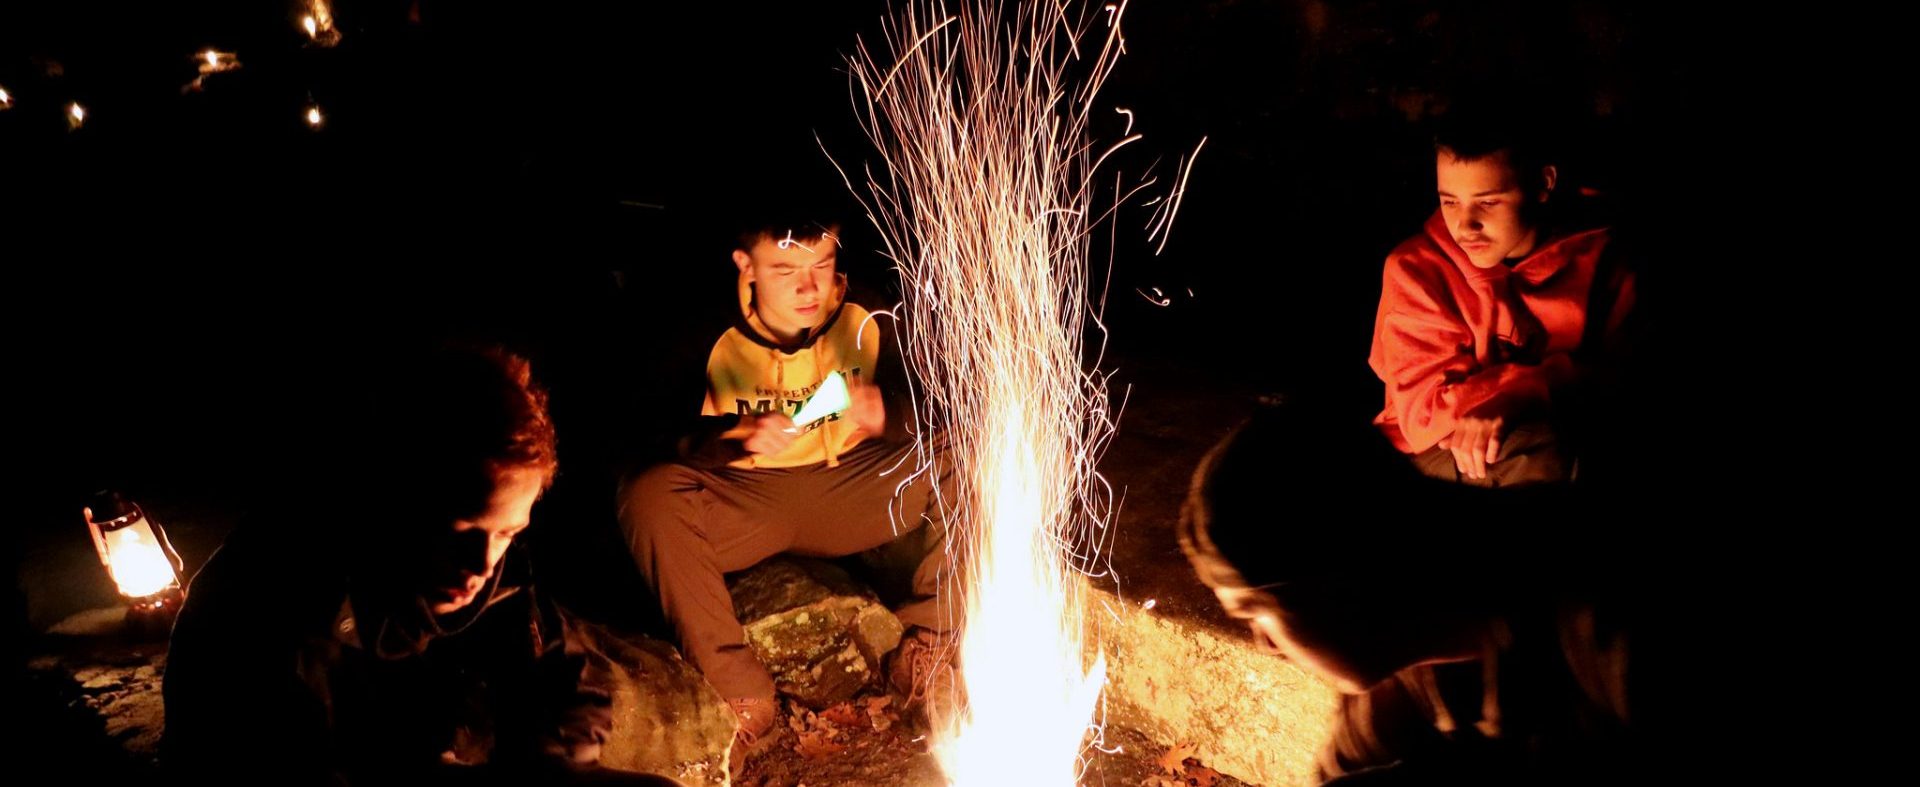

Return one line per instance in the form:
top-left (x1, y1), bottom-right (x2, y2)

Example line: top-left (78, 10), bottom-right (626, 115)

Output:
top-left (732, 559), bottom-right (904, 710)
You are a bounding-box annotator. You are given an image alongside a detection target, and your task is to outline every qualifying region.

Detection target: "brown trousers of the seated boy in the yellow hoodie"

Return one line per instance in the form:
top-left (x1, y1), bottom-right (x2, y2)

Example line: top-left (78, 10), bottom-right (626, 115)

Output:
top-left (618, 440), bottom-right (947, 699)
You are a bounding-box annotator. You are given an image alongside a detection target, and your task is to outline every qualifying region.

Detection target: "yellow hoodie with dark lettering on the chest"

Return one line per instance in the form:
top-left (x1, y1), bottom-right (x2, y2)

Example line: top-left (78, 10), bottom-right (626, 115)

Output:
top-left (701, 271), bottom-right (891, 468)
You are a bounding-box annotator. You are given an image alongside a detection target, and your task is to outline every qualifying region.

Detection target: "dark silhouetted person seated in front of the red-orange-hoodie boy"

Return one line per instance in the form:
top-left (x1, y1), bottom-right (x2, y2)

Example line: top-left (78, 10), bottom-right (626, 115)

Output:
top-left (1179, 405), bottom-right (1672, 785)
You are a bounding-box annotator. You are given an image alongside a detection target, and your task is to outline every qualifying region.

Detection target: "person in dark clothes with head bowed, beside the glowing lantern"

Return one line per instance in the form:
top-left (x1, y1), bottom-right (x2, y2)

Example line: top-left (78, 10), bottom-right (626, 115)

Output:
top-left (161, 349), bottom-right (676, 785)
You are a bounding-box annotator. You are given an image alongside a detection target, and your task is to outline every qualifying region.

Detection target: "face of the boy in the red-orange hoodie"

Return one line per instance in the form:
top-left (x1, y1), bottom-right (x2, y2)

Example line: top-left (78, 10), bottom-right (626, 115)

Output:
top-left (1434, 150), bottom-right (1555, 269)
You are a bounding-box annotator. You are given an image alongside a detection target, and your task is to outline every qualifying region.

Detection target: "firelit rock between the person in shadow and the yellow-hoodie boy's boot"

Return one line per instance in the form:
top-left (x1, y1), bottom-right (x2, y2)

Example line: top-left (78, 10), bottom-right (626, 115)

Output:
top-left (588, 626), bottom-right (733, 787)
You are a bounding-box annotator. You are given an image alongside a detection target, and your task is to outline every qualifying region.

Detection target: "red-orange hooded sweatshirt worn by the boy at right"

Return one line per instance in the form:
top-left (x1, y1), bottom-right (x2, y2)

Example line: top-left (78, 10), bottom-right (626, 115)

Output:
top-left (1367, 211), bottom-right (1634, 453)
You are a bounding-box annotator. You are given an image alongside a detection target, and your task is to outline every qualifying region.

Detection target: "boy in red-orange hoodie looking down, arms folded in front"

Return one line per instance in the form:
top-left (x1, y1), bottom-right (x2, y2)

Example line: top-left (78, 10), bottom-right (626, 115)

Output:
top-left (1367, 119), bottom-right (1634, 486)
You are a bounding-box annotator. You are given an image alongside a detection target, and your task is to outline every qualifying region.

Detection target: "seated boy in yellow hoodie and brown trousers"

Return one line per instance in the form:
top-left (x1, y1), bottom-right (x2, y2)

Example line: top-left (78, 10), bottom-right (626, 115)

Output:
top-left (620, 214), bottom-right (945, 739)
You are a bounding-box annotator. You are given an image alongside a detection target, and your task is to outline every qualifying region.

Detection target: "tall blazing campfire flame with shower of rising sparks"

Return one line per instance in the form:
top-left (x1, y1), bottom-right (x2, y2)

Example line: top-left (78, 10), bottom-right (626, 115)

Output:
top-left (841, 0), bottom-right (1133, 785)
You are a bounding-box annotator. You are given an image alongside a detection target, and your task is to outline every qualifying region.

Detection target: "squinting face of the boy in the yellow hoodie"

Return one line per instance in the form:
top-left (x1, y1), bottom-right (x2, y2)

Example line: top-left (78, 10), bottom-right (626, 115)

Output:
top-left (733, 234), bottom-right (839, 340)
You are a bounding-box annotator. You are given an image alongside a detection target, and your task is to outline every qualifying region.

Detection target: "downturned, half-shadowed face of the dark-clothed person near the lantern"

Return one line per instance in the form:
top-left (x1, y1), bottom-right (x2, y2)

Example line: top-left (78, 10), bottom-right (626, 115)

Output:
top-left (420, 468), bottom-right (545, 614)
